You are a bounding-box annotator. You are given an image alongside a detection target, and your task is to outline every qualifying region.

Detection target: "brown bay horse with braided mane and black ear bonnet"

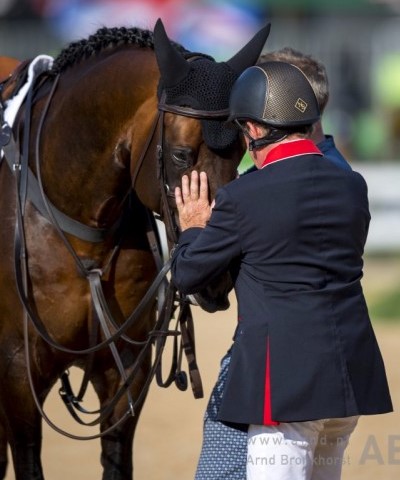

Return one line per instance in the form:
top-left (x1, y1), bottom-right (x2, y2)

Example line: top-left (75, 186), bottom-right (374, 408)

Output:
top-left (0, 16), bottom-right (269, 480)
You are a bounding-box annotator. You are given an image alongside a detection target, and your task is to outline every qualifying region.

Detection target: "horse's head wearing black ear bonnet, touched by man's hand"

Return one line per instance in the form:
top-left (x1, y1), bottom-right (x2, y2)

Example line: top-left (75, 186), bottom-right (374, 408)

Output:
top-left (154, 20), bottom-right (270, 311)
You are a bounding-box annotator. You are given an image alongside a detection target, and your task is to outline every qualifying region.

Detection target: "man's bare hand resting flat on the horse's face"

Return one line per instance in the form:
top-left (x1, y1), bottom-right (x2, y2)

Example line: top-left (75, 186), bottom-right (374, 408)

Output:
top-left (175, 170), bottom-right (212, 232)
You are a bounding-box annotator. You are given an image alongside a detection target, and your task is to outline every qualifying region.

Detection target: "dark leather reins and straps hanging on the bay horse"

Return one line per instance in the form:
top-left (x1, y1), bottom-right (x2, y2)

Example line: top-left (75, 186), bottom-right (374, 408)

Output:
top-left (0, 65), bottom-right (227, 440)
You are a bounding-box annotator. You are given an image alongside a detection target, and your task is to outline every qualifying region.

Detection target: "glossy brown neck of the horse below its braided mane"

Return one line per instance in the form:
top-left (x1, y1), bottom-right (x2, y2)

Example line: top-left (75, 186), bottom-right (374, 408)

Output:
top-left (36, 52), bottom-right (158, 226)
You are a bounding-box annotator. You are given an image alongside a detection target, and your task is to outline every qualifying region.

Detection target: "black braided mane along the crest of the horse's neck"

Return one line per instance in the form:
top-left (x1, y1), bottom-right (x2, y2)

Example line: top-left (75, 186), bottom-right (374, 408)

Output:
top-left (51, 27), bottom-right (190, 74)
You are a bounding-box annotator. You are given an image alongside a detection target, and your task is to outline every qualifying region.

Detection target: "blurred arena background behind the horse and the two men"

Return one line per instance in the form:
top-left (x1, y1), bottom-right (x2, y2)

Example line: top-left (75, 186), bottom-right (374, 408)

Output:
top-left (0, 0), bottom-right (400, 480)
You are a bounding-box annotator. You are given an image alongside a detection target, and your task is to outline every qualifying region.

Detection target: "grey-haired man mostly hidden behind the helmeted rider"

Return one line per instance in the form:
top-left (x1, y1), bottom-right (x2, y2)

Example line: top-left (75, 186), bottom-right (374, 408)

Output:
top-left (195, 47), bottom-right (351, 480)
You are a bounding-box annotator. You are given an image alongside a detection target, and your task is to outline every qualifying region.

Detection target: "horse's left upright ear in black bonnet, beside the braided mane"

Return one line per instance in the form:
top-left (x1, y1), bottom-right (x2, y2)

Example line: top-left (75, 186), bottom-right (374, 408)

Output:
top-left (154, 18), bottom-right (190, 87)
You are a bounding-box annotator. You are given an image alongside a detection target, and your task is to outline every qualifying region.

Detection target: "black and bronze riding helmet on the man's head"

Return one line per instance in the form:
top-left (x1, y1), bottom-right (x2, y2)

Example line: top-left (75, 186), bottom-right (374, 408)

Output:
top-left (229, 62), bottom-right (320, 131)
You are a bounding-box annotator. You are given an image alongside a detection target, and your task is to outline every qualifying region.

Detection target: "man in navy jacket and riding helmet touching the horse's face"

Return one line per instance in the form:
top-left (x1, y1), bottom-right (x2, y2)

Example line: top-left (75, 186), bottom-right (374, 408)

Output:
top-left (172, 62), bottom-right (392, 480)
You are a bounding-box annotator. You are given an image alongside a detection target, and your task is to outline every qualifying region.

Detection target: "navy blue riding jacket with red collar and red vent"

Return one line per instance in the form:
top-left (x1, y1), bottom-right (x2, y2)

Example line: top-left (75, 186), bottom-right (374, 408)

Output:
top-left (172, 151), bottom-right (392, 424)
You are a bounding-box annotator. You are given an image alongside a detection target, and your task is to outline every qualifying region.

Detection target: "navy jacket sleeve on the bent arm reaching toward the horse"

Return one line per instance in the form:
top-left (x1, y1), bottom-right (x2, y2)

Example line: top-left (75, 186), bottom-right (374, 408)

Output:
top-left (171, 189), bottom-right (240, 294)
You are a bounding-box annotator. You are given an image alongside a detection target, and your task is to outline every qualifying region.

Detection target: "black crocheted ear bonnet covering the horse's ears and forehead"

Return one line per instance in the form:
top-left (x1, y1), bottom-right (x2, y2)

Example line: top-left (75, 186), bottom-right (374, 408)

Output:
top-left (154, 20), bottom-right (270, 150)
